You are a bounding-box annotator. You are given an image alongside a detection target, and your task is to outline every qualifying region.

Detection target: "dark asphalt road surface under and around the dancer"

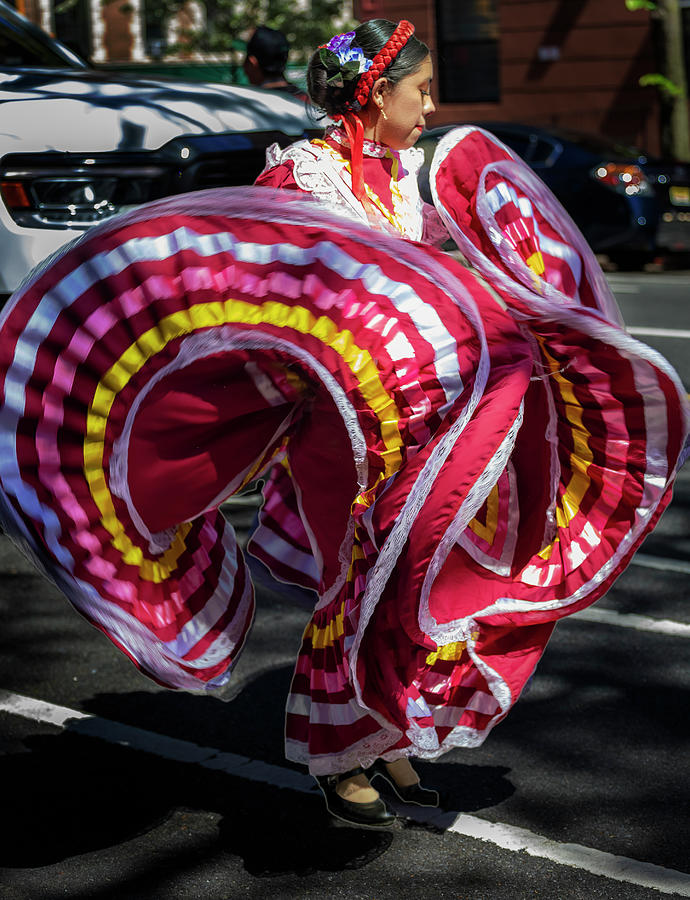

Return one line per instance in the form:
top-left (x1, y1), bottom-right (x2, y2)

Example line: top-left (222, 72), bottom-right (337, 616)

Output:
top-left (0, 273), bottom-right (690, 900)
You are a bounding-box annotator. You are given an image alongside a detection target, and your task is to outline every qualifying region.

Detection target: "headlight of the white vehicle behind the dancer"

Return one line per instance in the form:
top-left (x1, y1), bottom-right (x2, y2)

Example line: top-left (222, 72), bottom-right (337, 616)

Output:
top-left (0, 166), bottom-right (165, 228)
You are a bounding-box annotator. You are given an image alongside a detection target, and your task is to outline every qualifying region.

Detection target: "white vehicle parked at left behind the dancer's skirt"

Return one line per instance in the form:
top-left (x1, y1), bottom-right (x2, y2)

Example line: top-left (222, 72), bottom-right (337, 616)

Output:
top-left (0, 0), bottom-right (316, 303)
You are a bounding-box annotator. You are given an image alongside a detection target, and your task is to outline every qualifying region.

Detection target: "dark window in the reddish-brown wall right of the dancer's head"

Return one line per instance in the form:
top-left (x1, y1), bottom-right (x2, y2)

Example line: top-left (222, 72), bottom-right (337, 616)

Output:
top-left (436, 0), bottom-right (501, 103)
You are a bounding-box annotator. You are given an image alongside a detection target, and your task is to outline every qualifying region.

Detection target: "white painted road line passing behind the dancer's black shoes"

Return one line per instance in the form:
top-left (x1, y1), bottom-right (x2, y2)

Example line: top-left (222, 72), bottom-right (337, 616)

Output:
top-left (0, 691), bottom-right (690, 897)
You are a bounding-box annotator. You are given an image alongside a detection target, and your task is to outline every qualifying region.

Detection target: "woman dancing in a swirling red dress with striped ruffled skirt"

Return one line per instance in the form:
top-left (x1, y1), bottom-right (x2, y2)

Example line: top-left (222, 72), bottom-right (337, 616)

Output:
top-left (0, 19), bottom-right (690, 827)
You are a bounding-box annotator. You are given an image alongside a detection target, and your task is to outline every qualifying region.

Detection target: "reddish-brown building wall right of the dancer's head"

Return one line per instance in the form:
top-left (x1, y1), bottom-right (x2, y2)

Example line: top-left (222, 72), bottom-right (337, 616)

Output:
top-left (355, 0), bottom-right (660, 153)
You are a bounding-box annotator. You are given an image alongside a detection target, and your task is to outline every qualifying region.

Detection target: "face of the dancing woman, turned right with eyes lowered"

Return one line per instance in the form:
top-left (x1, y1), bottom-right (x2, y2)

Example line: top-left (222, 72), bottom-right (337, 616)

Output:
top-left (374, 56), bottom-right (436, 150)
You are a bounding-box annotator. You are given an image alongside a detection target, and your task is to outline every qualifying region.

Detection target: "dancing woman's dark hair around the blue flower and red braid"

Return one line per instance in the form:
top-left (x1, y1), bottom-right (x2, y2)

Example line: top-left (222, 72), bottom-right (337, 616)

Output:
top-left (307, 19), bottom-right (429, 116)
